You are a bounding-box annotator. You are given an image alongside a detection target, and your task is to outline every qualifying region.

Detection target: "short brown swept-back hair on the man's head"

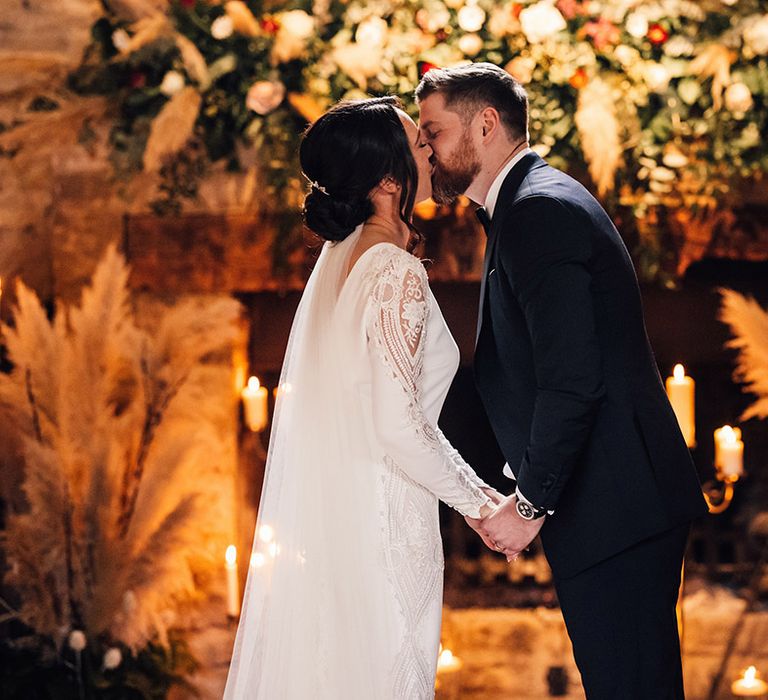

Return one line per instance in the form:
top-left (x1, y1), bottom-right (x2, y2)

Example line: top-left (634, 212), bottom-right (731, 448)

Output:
top-left (416, 63), bottom-right (528, 139)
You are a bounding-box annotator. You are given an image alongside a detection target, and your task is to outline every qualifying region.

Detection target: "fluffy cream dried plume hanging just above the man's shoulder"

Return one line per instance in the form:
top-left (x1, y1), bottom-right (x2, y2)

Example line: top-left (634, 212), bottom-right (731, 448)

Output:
top-left (575, 78), bottom-right (622, 200)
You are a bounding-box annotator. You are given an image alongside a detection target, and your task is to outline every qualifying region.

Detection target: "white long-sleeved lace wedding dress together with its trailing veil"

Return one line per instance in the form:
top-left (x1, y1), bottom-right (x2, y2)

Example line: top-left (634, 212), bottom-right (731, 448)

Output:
top-left (225, 229), bottom-right (490, 700)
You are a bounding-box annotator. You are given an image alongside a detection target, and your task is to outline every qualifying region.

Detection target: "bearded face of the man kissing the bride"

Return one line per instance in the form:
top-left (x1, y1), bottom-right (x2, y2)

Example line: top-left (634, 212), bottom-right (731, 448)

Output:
top-left (419, 93), bottom-right (480, 204)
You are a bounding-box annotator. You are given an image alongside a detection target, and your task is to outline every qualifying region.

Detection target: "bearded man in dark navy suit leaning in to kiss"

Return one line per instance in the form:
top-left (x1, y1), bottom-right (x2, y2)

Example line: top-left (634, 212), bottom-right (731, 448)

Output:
top-left (416, 63), bottom-right (707, 700)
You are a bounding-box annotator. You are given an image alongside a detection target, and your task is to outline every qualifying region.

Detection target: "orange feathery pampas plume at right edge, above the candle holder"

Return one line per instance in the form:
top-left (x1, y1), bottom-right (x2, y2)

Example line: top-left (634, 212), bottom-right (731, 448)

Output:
top-left (719, 289), bottom-right (768, 420)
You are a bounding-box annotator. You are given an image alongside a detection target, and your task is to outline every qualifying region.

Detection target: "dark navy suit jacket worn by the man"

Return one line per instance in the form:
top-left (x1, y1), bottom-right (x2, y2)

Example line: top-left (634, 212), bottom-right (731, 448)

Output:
top-left (474, 153), bottom-right (707, 578)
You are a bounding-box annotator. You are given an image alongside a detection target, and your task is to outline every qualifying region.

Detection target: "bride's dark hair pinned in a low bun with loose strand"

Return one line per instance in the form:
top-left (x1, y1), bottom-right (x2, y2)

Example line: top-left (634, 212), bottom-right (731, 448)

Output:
top-left (299, 96), bottom-right (420, 250)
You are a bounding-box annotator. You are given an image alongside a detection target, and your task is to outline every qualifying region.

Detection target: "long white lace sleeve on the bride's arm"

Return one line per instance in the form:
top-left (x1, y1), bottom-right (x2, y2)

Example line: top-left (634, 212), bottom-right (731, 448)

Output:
top-left (366, 253), bottom-right (491, 518)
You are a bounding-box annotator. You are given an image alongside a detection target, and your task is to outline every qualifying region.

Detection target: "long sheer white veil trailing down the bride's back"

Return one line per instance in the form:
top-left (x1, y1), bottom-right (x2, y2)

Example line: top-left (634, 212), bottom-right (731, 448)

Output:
top-left (224, 227), bottom-right (393, 700)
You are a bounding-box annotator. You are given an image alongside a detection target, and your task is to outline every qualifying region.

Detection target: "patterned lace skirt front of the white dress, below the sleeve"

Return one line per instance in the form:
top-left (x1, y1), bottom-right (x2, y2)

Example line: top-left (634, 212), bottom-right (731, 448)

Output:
top-left (383, 457), bottom-right (443, 700)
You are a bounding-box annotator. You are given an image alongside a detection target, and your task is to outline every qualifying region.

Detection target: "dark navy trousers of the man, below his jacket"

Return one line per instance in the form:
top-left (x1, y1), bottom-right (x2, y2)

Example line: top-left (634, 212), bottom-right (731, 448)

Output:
top-left (555, 524), bottom-right (690, 700)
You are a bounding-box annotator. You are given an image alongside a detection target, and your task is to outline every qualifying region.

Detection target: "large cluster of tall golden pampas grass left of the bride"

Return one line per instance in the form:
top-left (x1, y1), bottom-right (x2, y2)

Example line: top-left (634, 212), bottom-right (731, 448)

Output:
top-left (0, 247), bottom-right (240, 649)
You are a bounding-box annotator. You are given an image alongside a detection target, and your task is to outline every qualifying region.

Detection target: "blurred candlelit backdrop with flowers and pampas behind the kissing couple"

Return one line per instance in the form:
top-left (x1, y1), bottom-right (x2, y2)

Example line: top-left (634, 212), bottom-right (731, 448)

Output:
top-left (0, 0), bottom-right (768, 700)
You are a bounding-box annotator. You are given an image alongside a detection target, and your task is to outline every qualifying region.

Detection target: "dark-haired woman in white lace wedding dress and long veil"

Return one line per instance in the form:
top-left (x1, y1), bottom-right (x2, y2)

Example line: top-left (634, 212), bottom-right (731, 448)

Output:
top-left (224, 97), bottom-right (500, 700)
